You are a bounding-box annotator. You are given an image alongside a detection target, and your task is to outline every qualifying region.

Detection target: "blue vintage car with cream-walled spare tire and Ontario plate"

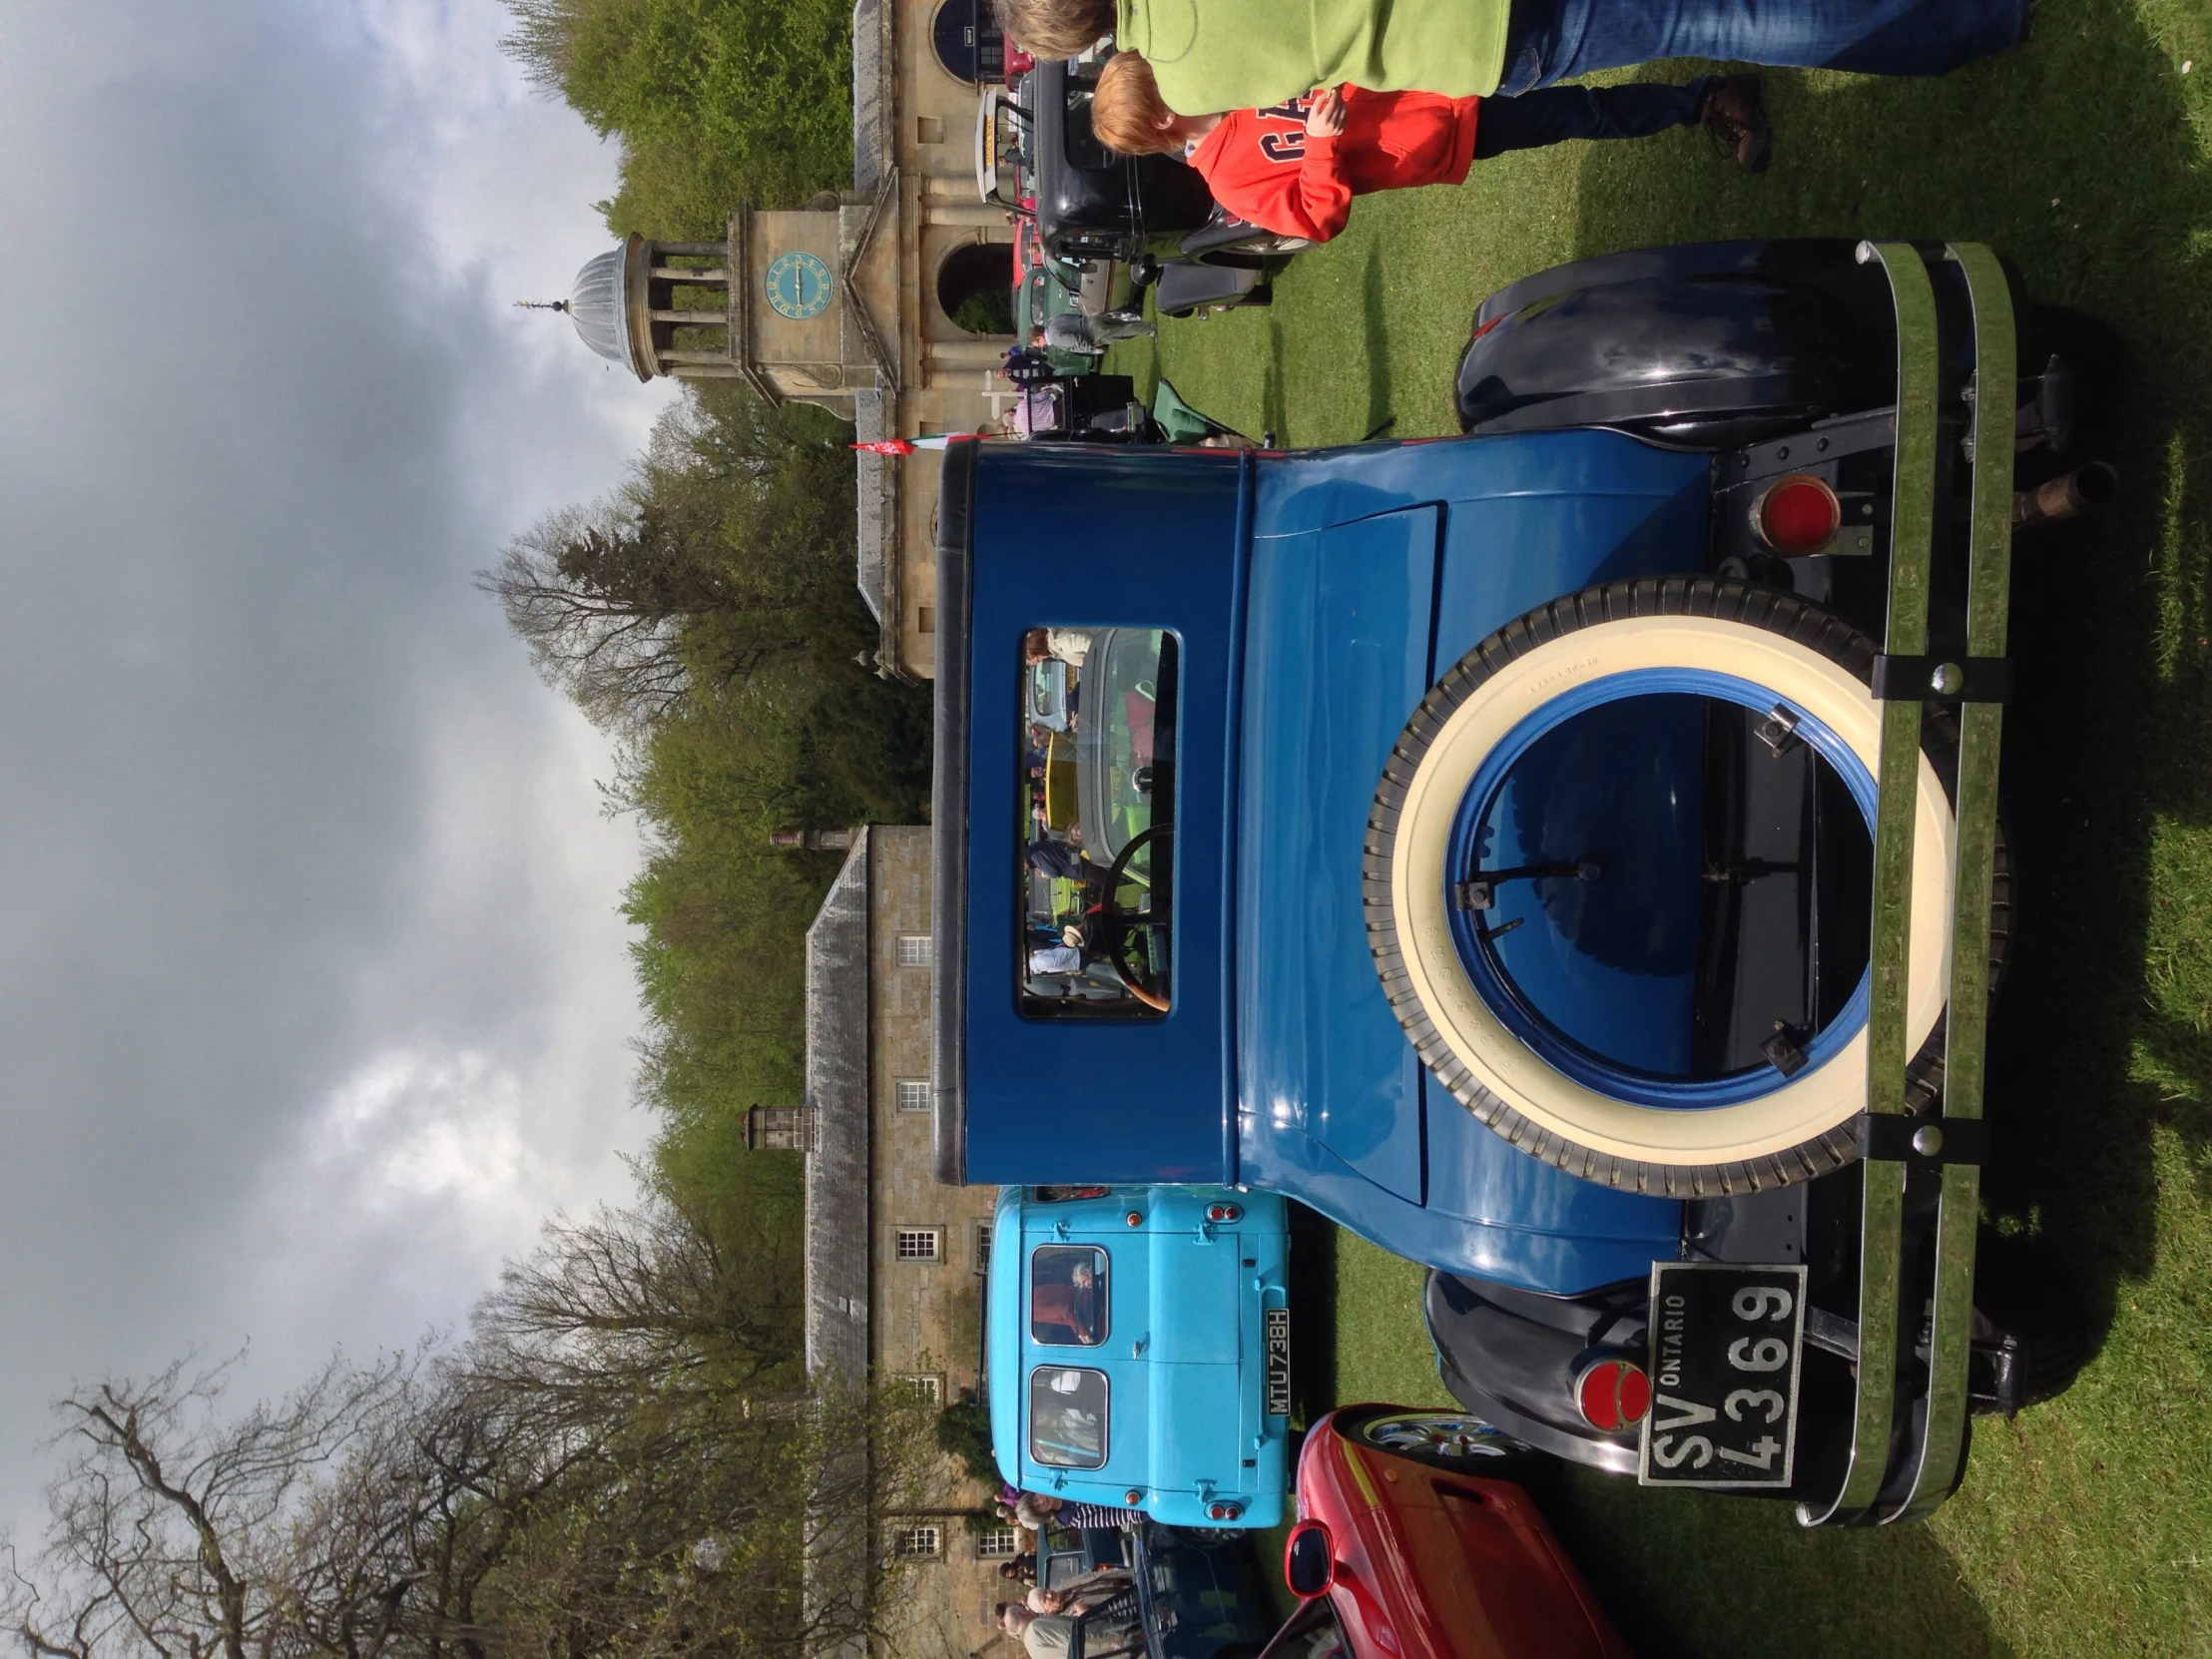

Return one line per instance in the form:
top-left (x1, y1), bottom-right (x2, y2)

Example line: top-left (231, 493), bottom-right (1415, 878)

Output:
top-left (935, 242), bottom-right (2099, 1522)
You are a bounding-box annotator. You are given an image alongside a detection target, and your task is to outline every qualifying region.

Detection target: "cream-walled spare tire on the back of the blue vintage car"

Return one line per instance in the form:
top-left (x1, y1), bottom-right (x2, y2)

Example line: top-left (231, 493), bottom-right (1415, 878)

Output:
top-left (1363, 577), bottom-right (2010, 1197)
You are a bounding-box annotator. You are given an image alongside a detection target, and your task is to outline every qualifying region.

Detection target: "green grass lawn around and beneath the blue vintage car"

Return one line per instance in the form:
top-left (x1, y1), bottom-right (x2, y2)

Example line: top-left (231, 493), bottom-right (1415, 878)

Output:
top-left (1117, 0), bottom-right (2212, 1659)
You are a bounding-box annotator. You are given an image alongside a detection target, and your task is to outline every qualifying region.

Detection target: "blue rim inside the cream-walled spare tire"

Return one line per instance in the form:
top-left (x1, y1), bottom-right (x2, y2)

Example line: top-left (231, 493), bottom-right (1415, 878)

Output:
top-left (1444, 668), bottom-right (1881, 1110)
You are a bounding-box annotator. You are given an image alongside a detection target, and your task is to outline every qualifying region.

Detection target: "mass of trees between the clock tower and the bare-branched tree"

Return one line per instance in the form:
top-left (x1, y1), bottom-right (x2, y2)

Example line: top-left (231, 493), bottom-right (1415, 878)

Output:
top-left (480, 382), bottom-right (929, 1241)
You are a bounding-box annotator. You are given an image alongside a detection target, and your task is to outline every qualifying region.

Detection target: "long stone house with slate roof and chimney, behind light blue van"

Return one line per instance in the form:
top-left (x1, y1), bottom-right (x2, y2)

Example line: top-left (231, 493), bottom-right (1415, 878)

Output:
top-left (787, 826), bottom-right (1015, 1659)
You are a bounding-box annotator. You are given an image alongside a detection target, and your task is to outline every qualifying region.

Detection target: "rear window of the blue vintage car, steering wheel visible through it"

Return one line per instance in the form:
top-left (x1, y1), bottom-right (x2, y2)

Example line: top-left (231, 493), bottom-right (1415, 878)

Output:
top-left (1013, 626), bottom-right (1181, 1020)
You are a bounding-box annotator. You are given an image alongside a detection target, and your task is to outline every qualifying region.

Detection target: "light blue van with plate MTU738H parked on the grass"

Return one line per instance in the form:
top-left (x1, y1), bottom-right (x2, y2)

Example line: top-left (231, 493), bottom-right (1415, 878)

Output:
top-left (989, 1186), bottom-right (1290, 1526)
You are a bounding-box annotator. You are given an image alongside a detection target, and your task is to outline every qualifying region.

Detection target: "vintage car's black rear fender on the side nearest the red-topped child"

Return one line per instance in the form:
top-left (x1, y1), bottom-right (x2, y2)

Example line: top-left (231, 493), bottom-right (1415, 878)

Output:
top-left (1453, 237), bottom-right (1896, 449)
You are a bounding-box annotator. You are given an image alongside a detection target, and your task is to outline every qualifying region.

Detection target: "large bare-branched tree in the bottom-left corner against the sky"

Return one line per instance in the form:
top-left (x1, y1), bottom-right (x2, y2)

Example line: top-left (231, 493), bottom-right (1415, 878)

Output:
top-left (0, 1204), bottom-right (955, 1659)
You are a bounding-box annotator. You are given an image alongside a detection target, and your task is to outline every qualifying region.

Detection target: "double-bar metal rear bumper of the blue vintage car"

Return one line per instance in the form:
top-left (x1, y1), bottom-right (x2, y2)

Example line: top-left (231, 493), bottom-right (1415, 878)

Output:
top-left (1799, 244), bottom-right (2017, 1526)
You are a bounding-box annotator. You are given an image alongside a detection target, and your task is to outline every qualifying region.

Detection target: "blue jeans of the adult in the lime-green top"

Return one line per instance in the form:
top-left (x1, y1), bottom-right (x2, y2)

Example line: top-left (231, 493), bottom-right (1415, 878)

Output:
top-left (1475, 0), bottom-right (2028, 94)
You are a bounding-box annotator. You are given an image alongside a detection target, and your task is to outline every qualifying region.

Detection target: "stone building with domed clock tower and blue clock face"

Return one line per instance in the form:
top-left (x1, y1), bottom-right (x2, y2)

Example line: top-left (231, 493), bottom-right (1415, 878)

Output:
top-left (564, 0), bottom-right (1013, 679)
